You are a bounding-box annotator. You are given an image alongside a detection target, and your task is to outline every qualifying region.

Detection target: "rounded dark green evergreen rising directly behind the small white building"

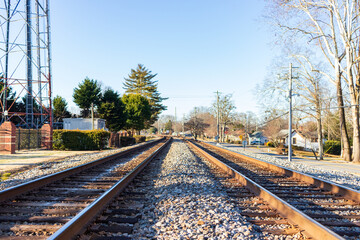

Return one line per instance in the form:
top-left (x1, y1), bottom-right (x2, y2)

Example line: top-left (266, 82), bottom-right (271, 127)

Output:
top-left (73, 78), bottom-right (101, 117)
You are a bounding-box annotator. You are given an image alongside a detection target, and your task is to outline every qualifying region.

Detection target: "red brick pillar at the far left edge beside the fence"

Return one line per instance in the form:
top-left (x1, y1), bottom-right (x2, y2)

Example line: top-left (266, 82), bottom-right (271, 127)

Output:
top-left (0, 122), bottom-right (16, 154)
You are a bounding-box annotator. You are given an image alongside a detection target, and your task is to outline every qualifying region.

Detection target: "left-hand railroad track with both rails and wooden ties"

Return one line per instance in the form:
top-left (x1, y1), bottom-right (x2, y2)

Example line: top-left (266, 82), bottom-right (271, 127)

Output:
top-left (0, 136), bottom-right (170, 239)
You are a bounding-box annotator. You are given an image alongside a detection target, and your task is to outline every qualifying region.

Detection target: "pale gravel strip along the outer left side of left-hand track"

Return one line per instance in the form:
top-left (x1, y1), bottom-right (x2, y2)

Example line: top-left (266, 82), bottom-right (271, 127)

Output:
top-left (0, 141), bottom-right (155, 190)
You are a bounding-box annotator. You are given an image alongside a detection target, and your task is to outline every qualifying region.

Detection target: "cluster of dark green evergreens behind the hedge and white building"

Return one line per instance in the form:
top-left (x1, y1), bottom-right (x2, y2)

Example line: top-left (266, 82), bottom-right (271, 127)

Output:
top-left (53, 64), bottom-right (167, 134)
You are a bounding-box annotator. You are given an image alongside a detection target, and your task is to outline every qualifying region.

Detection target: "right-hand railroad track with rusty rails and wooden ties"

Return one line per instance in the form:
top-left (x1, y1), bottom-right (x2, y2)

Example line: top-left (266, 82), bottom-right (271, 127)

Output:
top-left (190, 142), bottom-right (360, 239)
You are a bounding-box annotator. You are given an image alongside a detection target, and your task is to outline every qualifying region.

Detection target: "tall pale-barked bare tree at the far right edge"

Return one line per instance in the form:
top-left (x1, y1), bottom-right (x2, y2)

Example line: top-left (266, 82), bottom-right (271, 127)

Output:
top-left (268, 0), bottom-right (360, 162)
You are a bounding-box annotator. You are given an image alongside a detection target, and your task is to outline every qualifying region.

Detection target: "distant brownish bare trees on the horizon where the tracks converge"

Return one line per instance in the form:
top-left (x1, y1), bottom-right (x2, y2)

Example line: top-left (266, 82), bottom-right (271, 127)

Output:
top-left (158, 93), bottom-right (258, 142)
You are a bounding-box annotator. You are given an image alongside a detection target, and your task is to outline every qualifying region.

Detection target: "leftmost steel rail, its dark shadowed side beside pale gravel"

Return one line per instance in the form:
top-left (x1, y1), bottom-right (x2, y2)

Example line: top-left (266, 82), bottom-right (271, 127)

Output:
top-left (0, 138), bottom-right (164, 202)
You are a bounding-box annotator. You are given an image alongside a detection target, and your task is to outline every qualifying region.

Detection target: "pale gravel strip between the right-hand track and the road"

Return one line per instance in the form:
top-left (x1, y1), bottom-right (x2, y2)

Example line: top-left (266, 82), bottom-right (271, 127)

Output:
top-left (220, 142), bottom-right (360, 190)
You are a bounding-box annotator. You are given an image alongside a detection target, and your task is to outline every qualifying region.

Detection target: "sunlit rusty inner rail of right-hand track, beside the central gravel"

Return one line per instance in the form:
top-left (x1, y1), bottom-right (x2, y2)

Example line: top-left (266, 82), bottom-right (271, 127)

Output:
top-left (188, 141), bottom-right (344, 240)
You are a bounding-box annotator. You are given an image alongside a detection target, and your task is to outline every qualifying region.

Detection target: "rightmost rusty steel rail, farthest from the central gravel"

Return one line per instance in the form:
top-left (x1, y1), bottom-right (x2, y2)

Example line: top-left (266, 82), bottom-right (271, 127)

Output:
top-left (201, 142), bottom-right (360, 203)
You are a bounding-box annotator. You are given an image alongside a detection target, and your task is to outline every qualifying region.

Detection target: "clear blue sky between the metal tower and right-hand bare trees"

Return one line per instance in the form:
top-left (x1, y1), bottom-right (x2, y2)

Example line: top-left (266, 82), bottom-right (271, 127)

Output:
top-left (51, 0), bottom-right (274, 117)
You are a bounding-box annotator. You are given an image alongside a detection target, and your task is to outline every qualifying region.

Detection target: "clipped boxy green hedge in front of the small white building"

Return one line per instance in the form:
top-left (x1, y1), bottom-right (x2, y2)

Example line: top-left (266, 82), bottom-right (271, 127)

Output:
top-left (53, 130), bottom-right (110, 150)
